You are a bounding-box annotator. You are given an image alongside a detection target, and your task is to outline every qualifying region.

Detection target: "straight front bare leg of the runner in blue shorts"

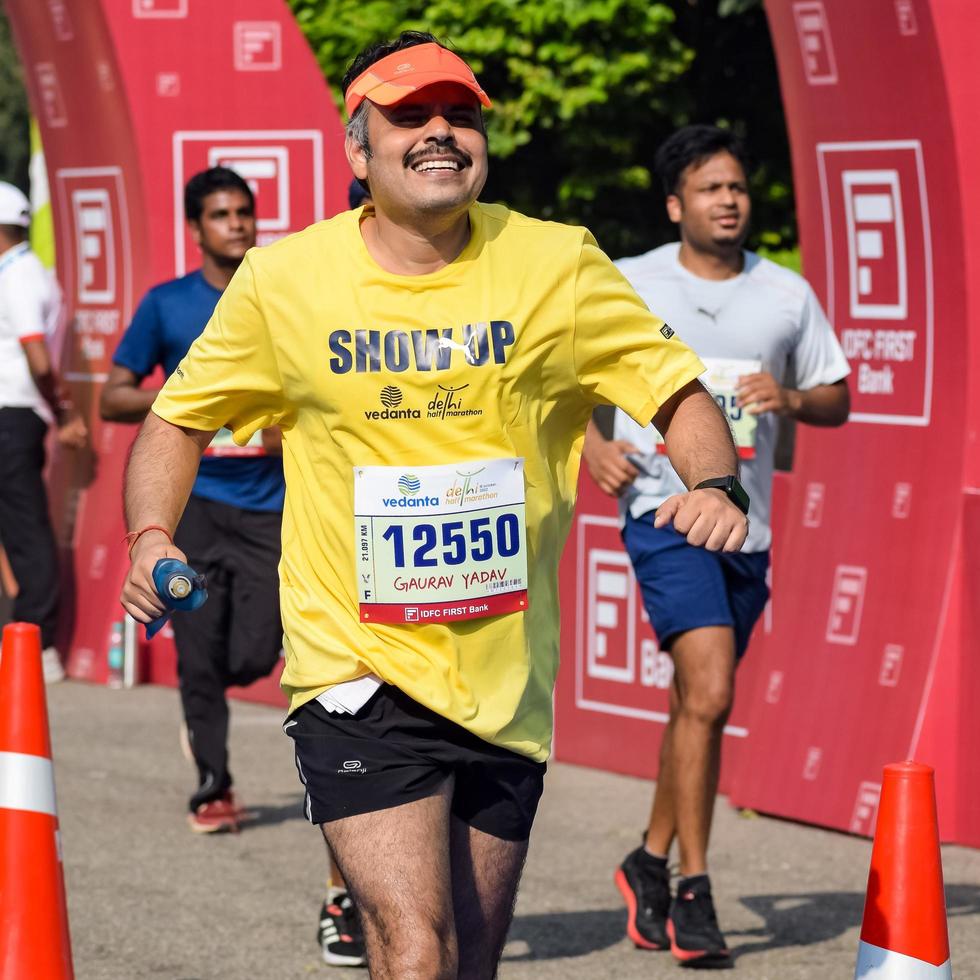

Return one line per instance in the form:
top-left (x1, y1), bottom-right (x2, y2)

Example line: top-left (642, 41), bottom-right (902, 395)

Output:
top-left (670, 626), bottom-right (735, 875)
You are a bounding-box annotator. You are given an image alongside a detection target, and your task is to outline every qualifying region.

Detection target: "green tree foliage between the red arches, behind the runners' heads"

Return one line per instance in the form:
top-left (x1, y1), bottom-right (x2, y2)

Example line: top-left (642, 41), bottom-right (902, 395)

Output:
top-left (289, 0), bottom-right (795, 256)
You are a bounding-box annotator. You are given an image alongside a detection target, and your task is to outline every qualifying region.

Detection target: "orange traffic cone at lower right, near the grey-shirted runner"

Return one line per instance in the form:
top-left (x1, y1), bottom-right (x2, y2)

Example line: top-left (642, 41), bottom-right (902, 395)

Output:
top-left (854, 762), bottom-right (952, 980)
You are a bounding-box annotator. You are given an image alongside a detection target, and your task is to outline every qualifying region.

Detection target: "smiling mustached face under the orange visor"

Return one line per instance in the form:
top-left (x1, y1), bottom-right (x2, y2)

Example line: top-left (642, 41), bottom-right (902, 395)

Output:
top-left (347, 82), bottom-right (487, 222)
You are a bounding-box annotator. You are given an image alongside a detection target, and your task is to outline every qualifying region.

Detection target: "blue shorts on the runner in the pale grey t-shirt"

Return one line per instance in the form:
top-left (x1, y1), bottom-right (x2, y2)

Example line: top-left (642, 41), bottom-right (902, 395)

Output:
top-left (623, 511), bottom-right (769, 657)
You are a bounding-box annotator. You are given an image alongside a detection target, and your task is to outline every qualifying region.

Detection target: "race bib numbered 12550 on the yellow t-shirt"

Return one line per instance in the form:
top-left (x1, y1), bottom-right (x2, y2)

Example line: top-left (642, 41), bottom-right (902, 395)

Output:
top-left (354, 459), bottom-right (528, 623)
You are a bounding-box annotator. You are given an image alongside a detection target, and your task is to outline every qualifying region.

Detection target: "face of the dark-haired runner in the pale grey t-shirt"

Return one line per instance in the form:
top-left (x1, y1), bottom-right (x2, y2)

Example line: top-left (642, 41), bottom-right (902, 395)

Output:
top-left (667, 151), bottom-right (752, 254)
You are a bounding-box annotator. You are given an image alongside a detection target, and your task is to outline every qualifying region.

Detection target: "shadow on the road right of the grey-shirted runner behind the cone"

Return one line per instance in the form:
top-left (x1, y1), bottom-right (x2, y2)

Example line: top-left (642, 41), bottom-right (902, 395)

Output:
top-left (728, 884), bottom-right (980, 957)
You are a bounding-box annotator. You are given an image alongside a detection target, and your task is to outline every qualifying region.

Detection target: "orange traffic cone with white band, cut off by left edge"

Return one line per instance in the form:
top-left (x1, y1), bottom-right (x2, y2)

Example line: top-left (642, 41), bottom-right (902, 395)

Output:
top-left (0, 623), bottom-right (74, 980)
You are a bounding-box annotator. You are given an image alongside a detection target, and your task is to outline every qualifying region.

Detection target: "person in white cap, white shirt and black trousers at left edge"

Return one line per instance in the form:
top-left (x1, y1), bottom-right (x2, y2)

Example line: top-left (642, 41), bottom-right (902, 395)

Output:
top-left (0, 181), bottom-right (88, 682)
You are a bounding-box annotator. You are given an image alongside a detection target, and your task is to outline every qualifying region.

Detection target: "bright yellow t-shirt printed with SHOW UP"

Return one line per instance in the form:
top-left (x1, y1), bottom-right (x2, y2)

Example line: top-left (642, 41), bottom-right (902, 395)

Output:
top-left (153, 204), bottom-right (704, 760)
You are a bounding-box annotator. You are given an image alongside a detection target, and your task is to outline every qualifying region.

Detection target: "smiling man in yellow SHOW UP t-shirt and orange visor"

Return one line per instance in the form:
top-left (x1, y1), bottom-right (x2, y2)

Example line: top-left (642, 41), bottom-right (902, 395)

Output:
top-left (122, 32), bottom-right (747, 978)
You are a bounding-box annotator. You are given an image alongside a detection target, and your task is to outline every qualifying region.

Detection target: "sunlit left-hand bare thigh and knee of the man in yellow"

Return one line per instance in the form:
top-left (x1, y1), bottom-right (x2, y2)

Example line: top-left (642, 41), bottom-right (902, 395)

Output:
top-left (320, 778), bottom-right (457, 980)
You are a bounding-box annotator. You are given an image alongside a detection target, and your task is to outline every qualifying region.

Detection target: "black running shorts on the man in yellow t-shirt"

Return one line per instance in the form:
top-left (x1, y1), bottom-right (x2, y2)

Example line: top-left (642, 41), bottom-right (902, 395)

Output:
top-left (283, 684), bottom-right (547, 841)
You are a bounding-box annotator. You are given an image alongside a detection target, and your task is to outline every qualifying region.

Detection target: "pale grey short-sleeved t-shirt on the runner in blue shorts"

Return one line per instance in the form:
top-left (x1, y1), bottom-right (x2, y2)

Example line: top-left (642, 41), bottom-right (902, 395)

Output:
top-left (614, 243), bottom-right (850, 552)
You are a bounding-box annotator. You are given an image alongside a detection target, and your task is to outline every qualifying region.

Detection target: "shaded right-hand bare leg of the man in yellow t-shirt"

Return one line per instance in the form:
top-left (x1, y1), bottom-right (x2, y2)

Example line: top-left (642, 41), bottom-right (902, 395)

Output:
top-left (451, 817), bottom-right (527, 980)
